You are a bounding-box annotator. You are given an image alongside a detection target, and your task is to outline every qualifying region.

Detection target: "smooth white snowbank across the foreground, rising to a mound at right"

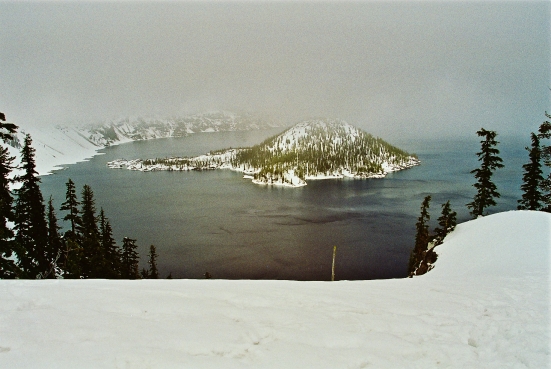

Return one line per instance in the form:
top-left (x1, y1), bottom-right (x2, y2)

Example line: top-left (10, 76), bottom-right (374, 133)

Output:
top-left (0, 212), bottom-right (551, 368)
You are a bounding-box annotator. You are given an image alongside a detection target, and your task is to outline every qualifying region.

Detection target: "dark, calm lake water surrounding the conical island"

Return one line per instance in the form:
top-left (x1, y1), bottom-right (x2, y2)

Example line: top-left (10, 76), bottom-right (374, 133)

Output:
top-left (37, 130), bottom-right (528, 280)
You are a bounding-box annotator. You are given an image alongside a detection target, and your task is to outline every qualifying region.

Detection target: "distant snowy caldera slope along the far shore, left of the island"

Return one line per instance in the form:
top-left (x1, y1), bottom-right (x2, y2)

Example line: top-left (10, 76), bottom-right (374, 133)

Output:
top-left (9, 112), bottom-right (277, 175)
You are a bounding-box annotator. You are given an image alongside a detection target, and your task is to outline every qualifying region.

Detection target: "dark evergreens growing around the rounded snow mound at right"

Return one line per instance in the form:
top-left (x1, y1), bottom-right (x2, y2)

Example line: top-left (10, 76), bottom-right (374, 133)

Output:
top-left (408, 112), bottom-right (551, 277)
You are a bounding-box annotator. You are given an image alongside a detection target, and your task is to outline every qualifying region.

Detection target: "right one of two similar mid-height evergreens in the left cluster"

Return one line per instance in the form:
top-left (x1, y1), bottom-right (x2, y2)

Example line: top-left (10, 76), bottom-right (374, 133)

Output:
top-left (78, 185), bottom-right (105, 278)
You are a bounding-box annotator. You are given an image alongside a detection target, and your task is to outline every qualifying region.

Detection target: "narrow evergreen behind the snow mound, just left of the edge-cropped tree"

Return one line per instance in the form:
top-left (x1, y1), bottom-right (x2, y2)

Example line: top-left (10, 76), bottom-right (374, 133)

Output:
top-left (518, 133), bottom-right (544, 210)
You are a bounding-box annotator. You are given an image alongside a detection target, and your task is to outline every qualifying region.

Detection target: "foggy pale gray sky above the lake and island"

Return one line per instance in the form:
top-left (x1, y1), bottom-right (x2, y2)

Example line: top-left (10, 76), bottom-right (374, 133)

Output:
top-left (0, 1), bottom-right (551, 138)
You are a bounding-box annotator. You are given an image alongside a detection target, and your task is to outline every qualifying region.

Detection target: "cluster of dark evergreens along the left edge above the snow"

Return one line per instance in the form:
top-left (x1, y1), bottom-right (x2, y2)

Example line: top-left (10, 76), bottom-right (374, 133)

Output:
top-left (0, 113), bottom-right (159, 279)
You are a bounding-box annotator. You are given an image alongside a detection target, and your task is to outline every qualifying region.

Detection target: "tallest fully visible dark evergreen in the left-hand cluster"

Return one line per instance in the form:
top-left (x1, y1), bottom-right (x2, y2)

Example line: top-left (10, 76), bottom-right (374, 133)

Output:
top-left (14, 134), bottom-right (50, 278)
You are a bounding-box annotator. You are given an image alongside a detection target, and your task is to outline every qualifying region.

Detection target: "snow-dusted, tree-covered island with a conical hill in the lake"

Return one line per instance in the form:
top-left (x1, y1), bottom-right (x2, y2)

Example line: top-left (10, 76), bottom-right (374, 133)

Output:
top-left (107, 119), bottom-right (419, 187)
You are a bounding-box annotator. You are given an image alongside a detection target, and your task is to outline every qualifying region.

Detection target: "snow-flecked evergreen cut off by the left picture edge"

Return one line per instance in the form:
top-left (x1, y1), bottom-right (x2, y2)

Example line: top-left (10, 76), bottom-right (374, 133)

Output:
top-left (0, 113), bottom-right (19, 278)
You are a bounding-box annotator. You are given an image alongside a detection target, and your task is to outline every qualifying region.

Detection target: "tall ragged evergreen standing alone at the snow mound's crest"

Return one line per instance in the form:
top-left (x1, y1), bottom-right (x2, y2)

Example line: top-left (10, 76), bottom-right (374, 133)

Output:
top-left (467, 128), bottom-right (503, 218)
